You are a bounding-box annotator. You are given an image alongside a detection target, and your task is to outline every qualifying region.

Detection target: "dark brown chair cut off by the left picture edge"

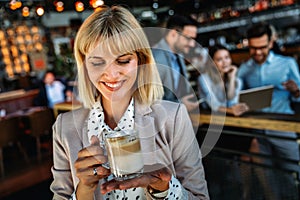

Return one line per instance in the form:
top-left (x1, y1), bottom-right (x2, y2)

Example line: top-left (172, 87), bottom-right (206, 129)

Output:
top-left (0, 117), bottom-right (29, 177)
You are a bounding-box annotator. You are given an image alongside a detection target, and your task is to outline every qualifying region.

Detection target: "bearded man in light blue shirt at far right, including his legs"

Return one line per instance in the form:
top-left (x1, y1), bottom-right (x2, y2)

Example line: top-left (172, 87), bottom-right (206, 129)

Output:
top-left (238, 23), bottom-right (300, 199)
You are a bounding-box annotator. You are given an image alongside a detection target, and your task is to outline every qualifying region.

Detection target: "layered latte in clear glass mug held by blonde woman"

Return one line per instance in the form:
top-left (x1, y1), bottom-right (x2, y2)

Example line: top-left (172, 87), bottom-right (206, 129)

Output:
top-left (105, 130), bottom-right (144, 180)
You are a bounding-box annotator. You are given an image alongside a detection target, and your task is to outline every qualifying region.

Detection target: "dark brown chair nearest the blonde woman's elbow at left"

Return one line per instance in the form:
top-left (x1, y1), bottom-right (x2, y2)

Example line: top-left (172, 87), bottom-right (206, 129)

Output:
top-left (25, 107), bottom-right (55, 161)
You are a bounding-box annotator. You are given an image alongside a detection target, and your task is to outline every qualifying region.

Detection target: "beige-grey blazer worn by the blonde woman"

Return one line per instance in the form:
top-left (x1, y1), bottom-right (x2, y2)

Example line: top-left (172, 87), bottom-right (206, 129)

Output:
top-left (50, 101), bottom-right (209, 200)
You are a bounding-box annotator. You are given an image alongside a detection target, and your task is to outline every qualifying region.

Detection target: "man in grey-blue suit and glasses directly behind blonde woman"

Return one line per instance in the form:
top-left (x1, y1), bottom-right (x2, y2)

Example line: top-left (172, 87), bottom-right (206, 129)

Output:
top-left (152, 15), bottom-right (199, 111)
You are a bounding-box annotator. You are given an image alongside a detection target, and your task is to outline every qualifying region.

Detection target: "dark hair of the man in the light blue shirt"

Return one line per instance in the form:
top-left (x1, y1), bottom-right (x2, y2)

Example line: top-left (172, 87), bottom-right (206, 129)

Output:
top-left (247, 22), bottom-right (272, 41)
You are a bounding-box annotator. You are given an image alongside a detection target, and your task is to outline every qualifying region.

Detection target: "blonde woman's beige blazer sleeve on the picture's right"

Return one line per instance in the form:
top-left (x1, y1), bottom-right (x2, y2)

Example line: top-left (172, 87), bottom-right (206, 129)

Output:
top-left (172, 104), bottom-right (209, 199)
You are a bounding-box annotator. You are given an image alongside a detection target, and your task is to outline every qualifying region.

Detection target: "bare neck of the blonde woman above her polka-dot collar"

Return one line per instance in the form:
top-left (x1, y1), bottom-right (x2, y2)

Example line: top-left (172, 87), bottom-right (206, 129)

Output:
top-left (102, 98), bottom-right (131, 129)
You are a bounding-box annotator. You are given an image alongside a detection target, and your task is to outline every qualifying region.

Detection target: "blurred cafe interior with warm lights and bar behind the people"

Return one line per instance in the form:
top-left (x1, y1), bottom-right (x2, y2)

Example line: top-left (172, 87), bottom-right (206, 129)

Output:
top-left (0, 0), bottom-right (300, 200)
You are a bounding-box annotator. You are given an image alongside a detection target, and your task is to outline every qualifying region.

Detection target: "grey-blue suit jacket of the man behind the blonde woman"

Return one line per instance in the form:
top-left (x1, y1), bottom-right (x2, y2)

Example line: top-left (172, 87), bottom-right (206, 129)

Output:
top-left (152, 39), bottom-right (192, 102)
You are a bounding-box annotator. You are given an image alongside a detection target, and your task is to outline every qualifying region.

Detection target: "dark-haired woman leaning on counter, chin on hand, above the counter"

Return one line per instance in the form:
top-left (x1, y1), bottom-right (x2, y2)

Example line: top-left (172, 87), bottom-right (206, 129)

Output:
top-left (198, 45), bottom-right (249, 116)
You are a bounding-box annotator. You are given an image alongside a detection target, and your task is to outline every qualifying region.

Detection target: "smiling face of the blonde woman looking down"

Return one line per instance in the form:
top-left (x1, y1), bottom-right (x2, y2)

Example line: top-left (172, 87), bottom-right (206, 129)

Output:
top-left (85, 48), bottom-right (138, 102)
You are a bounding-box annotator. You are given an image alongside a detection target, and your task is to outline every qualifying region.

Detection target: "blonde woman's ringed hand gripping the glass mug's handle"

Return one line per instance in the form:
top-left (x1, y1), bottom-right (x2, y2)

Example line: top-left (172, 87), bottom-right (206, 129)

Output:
top-left (74, 136), bottom-right (110, 199)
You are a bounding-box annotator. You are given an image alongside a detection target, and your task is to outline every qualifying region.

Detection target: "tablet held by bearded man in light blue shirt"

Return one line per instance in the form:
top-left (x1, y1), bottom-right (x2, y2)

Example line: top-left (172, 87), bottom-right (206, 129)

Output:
top-left (239, 85), bottom-right (274, 110)
